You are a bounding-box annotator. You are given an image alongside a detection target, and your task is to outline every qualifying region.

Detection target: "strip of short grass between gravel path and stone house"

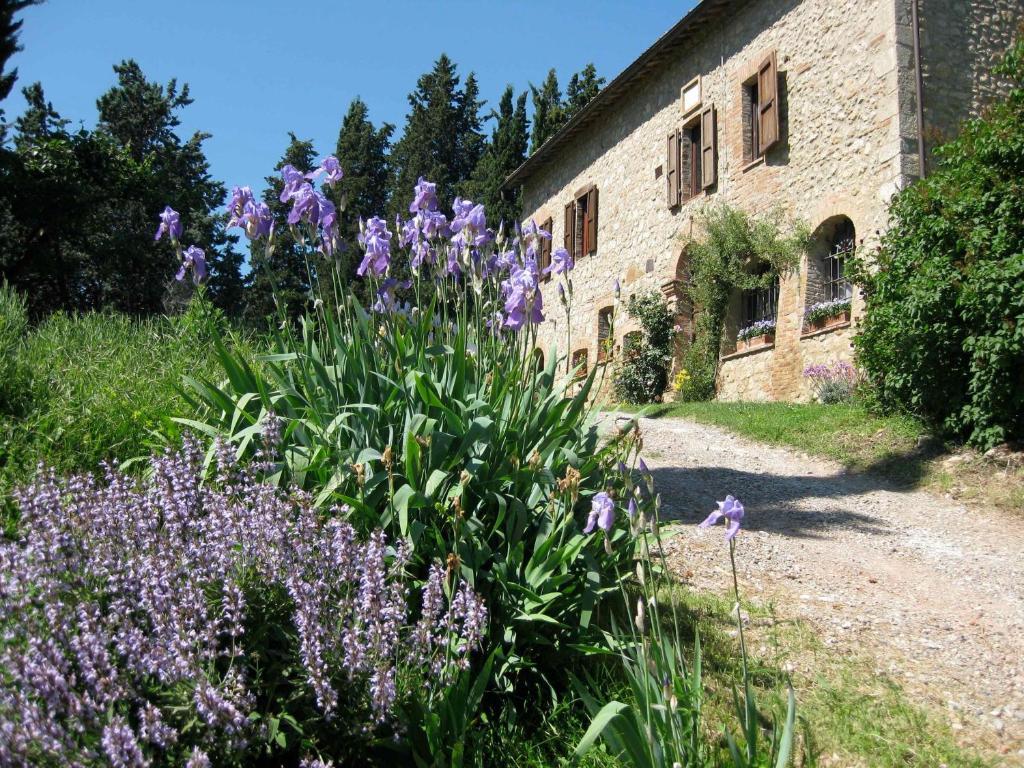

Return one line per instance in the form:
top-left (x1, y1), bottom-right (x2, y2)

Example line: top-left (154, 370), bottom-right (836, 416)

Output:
top-left (616, 402), bottom-right (1024, 514)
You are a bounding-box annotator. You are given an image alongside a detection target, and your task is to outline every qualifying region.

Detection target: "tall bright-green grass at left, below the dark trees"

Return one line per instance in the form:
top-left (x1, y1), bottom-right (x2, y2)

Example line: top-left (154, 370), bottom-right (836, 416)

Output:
top-left (0, 289), bottom-right (246, 514)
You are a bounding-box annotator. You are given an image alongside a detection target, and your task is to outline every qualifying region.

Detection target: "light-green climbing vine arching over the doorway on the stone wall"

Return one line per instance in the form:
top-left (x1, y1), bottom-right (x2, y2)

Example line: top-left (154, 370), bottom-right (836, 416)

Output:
top-left (680, 204), bottom-right (810, 400)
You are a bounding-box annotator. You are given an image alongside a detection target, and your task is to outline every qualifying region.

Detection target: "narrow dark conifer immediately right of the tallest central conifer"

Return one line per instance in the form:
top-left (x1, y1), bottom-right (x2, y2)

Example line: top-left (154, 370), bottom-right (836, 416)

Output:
top-left (472, 85), bottom-right (528, 229)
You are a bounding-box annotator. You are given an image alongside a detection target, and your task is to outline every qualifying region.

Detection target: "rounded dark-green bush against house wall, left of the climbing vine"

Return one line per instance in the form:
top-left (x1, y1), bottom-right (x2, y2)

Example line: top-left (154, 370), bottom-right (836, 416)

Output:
top-left (614, 291), bottom-right (675, 403)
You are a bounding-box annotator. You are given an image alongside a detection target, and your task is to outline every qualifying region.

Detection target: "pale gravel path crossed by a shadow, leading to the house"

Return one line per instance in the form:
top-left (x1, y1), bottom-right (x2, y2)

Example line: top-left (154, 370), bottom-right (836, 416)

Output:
top-left (622, 419), bottom-right (1024, 765)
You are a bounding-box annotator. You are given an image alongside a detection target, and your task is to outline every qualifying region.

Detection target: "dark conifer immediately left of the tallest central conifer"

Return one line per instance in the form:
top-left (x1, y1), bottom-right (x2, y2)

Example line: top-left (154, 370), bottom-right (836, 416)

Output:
top-left (329, 97), bottom-right (394, 280)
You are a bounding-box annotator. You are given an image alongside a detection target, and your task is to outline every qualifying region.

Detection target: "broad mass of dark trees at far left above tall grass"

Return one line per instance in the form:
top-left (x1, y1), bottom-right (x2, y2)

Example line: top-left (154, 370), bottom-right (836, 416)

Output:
top-left (0, 61), bottom-right (241, 315)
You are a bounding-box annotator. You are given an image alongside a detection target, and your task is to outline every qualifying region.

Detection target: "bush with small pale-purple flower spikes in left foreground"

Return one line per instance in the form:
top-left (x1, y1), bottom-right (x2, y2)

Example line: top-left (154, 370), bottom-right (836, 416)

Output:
top-left (0, 430), bottom-right (486, 766)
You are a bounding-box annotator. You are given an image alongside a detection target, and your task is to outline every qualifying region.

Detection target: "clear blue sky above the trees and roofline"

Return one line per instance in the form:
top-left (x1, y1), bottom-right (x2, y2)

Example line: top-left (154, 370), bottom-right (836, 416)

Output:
top-left (4, 0), bottom-right (694, 198)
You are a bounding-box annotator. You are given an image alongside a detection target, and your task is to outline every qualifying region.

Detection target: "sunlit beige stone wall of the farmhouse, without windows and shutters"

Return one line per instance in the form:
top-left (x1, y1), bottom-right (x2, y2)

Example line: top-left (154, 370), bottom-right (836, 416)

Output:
top-left (523, 0), bottom-right (1018, 399)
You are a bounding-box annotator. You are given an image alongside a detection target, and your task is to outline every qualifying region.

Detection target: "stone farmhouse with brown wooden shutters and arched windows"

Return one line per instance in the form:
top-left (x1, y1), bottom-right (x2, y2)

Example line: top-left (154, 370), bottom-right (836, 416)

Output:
top-left (506, 0), bottom-right (1024, 399)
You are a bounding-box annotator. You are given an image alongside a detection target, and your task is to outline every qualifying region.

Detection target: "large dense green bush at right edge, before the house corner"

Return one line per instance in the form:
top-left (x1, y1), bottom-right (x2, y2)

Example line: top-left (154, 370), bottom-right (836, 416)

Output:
top-left (856, 41), bottom-right (1024, 447)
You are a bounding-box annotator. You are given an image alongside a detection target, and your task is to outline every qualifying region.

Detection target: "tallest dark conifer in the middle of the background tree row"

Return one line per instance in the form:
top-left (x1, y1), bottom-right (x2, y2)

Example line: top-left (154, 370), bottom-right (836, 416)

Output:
top-left (388, 53), bottom-right (485, 220)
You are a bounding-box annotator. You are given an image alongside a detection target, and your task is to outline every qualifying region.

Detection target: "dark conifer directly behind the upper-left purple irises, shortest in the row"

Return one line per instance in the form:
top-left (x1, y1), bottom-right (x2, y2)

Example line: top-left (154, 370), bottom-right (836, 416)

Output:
top-left (244, 133), bottom-right (316, 327)
